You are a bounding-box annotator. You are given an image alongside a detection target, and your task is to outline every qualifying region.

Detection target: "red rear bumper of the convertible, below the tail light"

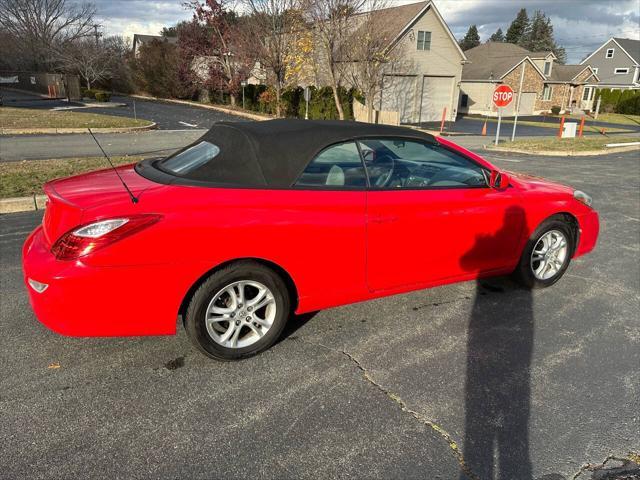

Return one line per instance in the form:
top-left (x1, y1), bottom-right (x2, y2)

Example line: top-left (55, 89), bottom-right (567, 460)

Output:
top-left (22, 227), bottom-right (198, 336)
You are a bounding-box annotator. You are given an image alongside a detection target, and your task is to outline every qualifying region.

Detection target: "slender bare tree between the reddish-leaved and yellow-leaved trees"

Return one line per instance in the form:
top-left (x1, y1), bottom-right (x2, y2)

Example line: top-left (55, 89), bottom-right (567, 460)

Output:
top-left (243, 0), bottom-right (304, 116)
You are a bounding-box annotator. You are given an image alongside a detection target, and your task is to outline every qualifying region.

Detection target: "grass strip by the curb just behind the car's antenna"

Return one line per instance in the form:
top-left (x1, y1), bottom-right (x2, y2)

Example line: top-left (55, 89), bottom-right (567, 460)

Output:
top-left (0, 157), bottom-right (142, 198)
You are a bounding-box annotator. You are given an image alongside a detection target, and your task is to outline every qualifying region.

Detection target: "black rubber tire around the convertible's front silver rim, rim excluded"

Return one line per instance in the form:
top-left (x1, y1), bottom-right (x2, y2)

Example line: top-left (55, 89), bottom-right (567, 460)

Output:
top-left (513, 217), bottom-right (574, 289)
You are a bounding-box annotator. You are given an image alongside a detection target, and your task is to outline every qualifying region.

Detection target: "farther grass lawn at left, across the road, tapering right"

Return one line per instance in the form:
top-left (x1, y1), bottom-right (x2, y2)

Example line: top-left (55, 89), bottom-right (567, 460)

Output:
top-left (0, 107), bottom-right (151, 128)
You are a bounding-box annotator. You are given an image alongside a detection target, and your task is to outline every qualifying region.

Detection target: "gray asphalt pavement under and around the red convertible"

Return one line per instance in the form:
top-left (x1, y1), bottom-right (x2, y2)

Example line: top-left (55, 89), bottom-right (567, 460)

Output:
top-left (0, 152), bottom-right (640, 480)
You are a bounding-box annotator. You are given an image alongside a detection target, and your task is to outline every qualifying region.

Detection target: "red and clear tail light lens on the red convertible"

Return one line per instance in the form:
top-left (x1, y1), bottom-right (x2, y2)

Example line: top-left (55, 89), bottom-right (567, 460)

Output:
top-left (51, 214), bottom-right (161, 260)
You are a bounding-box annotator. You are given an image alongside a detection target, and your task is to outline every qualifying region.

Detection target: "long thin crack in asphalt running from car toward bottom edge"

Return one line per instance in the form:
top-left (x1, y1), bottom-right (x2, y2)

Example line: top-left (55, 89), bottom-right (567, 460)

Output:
top-left (295, 337), bottom-right (480, 480)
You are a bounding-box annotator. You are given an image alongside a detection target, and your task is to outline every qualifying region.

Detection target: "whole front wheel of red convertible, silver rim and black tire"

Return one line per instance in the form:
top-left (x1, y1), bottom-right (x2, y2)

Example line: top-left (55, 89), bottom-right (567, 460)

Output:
top-left (514, 218), bottom-right (573, 288)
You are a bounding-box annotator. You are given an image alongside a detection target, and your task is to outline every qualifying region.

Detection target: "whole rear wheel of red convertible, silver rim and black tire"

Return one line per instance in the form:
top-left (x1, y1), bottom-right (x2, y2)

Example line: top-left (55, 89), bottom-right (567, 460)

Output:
top-left (184, 262), bottom-right (290, 360)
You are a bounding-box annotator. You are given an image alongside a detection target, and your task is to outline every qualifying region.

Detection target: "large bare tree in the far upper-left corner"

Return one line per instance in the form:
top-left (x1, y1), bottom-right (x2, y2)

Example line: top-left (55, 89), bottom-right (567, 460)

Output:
top-left (0, 0), bottom-right (95, 70)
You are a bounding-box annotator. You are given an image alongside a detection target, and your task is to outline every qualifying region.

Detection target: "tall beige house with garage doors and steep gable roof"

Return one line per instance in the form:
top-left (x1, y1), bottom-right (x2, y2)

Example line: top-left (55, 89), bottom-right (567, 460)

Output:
top-left (297, 1), bottom-right (466, 124)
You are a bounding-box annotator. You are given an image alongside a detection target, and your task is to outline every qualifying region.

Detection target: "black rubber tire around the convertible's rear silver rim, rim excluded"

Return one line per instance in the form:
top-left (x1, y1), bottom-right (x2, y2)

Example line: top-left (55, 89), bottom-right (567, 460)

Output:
top-left (184, 261), bottom-right (291, 361)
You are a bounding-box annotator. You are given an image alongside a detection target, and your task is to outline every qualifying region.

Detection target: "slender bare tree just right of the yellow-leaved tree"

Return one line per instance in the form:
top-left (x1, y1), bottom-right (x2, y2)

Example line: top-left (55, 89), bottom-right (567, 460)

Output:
top-left (304, 0), bottom-right (366, 120)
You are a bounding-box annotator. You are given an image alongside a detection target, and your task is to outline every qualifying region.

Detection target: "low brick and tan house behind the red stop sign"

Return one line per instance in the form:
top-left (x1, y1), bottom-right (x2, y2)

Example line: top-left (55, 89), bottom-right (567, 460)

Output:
top-left (459, 42), bottom-right (598, 116)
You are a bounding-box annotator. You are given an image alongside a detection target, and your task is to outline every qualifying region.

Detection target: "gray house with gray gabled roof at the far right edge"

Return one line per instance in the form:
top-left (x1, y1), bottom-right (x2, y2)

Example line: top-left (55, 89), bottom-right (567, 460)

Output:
top-left (581, 37), bottom-right (640, 89)
